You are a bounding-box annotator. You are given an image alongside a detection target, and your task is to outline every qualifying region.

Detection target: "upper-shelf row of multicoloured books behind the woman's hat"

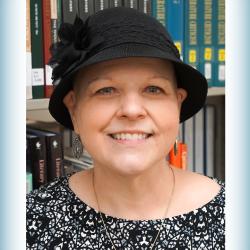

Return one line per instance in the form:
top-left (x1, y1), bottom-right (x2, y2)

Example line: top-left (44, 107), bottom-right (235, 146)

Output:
top-left (26, 0), bottom-right (225, 99)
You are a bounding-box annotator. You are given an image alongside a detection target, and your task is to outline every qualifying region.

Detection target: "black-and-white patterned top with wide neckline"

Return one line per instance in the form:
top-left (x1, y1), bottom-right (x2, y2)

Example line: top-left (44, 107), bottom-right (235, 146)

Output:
top-left (27, 176), bottom-right (225, 250)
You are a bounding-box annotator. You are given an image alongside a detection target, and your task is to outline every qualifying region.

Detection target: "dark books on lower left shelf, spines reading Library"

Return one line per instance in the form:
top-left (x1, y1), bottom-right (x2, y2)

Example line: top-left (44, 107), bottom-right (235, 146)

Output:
top-left (26, 122), bottom-right (92, 193)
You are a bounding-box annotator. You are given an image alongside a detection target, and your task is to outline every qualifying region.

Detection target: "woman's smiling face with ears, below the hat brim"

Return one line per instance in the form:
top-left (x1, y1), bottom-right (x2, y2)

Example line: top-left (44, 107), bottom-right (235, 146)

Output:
top-left (64, 57), bottom-right (186, 175)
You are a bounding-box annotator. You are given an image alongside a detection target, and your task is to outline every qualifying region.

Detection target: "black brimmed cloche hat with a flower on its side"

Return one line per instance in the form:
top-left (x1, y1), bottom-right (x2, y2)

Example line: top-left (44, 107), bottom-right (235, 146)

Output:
top-left (49, 7), bottom-right (208, 129)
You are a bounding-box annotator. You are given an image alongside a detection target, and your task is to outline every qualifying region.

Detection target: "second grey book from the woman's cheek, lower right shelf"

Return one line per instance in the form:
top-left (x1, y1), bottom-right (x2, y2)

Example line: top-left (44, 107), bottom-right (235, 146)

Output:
top-left (194, 108), bottom-right (205, 174)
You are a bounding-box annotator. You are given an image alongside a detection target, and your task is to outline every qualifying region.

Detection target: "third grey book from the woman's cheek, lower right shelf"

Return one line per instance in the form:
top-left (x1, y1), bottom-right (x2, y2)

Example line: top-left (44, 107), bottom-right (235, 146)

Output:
top-left (204, 105), bottom-right (216, 177)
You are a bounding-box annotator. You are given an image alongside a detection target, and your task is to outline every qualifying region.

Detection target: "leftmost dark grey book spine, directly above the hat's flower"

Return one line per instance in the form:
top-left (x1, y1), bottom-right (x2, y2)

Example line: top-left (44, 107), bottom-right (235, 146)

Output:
top-left (62, 0), bottom-right (78, 24)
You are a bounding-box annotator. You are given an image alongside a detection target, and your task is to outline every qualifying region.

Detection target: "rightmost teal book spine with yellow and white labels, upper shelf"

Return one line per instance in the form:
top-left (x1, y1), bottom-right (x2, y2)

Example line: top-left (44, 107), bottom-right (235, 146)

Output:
top-left (214, 0), bottom-right (225, 87)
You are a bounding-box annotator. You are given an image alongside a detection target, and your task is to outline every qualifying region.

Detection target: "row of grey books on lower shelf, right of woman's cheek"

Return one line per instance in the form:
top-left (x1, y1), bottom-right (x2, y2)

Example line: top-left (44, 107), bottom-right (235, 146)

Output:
top-left (179, 104), bottom-right (219, 177)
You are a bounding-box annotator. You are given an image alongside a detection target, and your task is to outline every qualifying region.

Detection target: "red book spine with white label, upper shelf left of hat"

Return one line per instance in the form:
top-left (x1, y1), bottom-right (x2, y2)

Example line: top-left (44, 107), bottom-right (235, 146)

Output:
top-left (42, 0), bottom-right (55, 98)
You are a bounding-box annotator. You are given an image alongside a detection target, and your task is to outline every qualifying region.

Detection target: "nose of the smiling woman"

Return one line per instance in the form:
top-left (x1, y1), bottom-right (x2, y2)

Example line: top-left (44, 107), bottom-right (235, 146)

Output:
top-left (117, 93), bottom-right (147, 120)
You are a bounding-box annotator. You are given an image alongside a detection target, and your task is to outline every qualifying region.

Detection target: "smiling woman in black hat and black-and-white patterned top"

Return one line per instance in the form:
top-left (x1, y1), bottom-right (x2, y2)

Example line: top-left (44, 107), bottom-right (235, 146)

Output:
top-left (27, 7), bottom-right (224, 249)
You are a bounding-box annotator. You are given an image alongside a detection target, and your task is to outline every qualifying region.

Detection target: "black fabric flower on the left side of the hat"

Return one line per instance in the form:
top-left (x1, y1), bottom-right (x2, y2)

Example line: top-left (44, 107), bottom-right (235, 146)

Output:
top-left (49, 16), bottom-right (104, 83)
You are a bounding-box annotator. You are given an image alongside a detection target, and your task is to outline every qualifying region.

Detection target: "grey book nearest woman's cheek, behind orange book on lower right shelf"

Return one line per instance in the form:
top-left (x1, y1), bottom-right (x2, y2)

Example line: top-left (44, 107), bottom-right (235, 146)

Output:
top-left (183, 117), bottom-right (195, 172)
